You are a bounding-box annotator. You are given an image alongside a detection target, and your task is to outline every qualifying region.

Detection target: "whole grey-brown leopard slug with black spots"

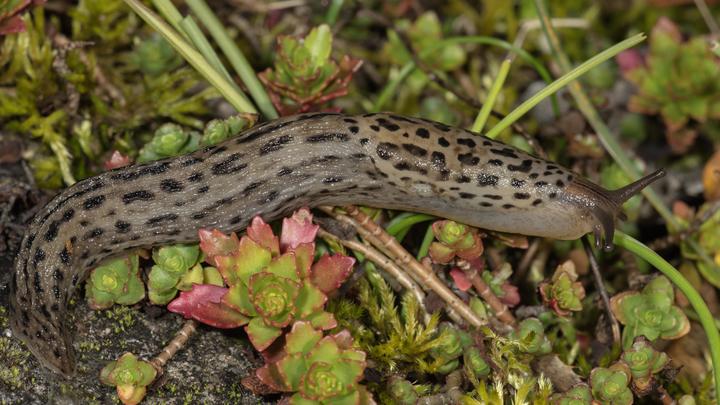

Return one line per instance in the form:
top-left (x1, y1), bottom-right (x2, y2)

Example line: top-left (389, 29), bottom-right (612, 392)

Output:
top-left (10, 113), bottom-right (663, 376)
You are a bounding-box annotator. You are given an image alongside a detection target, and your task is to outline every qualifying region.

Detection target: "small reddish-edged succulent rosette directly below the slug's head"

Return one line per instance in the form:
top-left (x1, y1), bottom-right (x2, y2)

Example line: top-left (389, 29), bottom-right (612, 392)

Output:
top-left (539, 260), bottom-right (585, 316)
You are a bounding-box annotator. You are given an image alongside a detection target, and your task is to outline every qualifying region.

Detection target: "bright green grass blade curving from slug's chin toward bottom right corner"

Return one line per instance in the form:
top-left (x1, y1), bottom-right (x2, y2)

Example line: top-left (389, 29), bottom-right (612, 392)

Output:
top-left (613, 231), bottom-right (720, 396)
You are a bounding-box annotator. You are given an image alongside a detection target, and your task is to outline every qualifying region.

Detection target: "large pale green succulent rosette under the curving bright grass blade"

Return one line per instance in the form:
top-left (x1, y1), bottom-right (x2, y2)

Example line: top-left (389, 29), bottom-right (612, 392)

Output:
top-left (610, 276), bottom-right (690, 348)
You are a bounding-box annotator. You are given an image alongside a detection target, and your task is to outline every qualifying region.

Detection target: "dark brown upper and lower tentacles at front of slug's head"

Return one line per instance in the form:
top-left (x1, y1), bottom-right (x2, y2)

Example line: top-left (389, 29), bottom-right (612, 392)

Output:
top-left (593, 169), bottom-right (665, 250)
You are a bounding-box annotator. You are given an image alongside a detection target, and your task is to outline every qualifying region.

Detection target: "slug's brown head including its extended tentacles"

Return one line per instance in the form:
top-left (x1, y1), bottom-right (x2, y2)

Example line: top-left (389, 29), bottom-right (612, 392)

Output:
top-left (568, 169), bottom-right (665, 250)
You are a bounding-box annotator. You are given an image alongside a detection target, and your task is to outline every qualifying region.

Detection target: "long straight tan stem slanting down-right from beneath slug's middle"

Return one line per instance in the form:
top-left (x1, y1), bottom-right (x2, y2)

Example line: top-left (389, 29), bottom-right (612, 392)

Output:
top-left (344, 205), bottom-right (486, 327)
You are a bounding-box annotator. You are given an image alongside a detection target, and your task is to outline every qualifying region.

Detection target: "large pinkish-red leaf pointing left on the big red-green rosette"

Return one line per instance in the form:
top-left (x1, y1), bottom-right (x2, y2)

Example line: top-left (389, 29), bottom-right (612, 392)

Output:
top-left (167, 284), bottom-right (248, 329)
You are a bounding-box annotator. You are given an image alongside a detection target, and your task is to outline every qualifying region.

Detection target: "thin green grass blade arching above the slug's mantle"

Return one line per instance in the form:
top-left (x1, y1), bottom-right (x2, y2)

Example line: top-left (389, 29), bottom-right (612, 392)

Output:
top-left (370, 36), bottom-right (552, 112)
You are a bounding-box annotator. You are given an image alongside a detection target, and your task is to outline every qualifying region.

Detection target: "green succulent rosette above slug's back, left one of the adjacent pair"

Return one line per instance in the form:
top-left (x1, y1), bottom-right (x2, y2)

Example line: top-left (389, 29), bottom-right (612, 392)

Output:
top-left (137, 123), bottom-right (200, 163)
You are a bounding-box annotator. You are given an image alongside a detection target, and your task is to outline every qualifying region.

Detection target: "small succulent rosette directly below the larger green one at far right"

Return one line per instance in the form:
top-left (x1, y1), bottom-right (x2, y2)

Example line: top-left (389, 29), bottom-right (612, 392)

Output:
top-left (620, 337), bottom-right (670, 395)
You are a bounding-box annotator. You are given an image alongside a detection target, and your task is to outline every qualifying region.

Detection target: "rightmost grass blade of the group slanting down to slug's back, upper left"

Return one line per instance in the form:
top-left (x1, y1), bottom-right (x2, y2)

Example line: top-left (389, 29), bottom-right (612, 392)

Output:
top-left (187, 0), bottom-right (278, 119)
